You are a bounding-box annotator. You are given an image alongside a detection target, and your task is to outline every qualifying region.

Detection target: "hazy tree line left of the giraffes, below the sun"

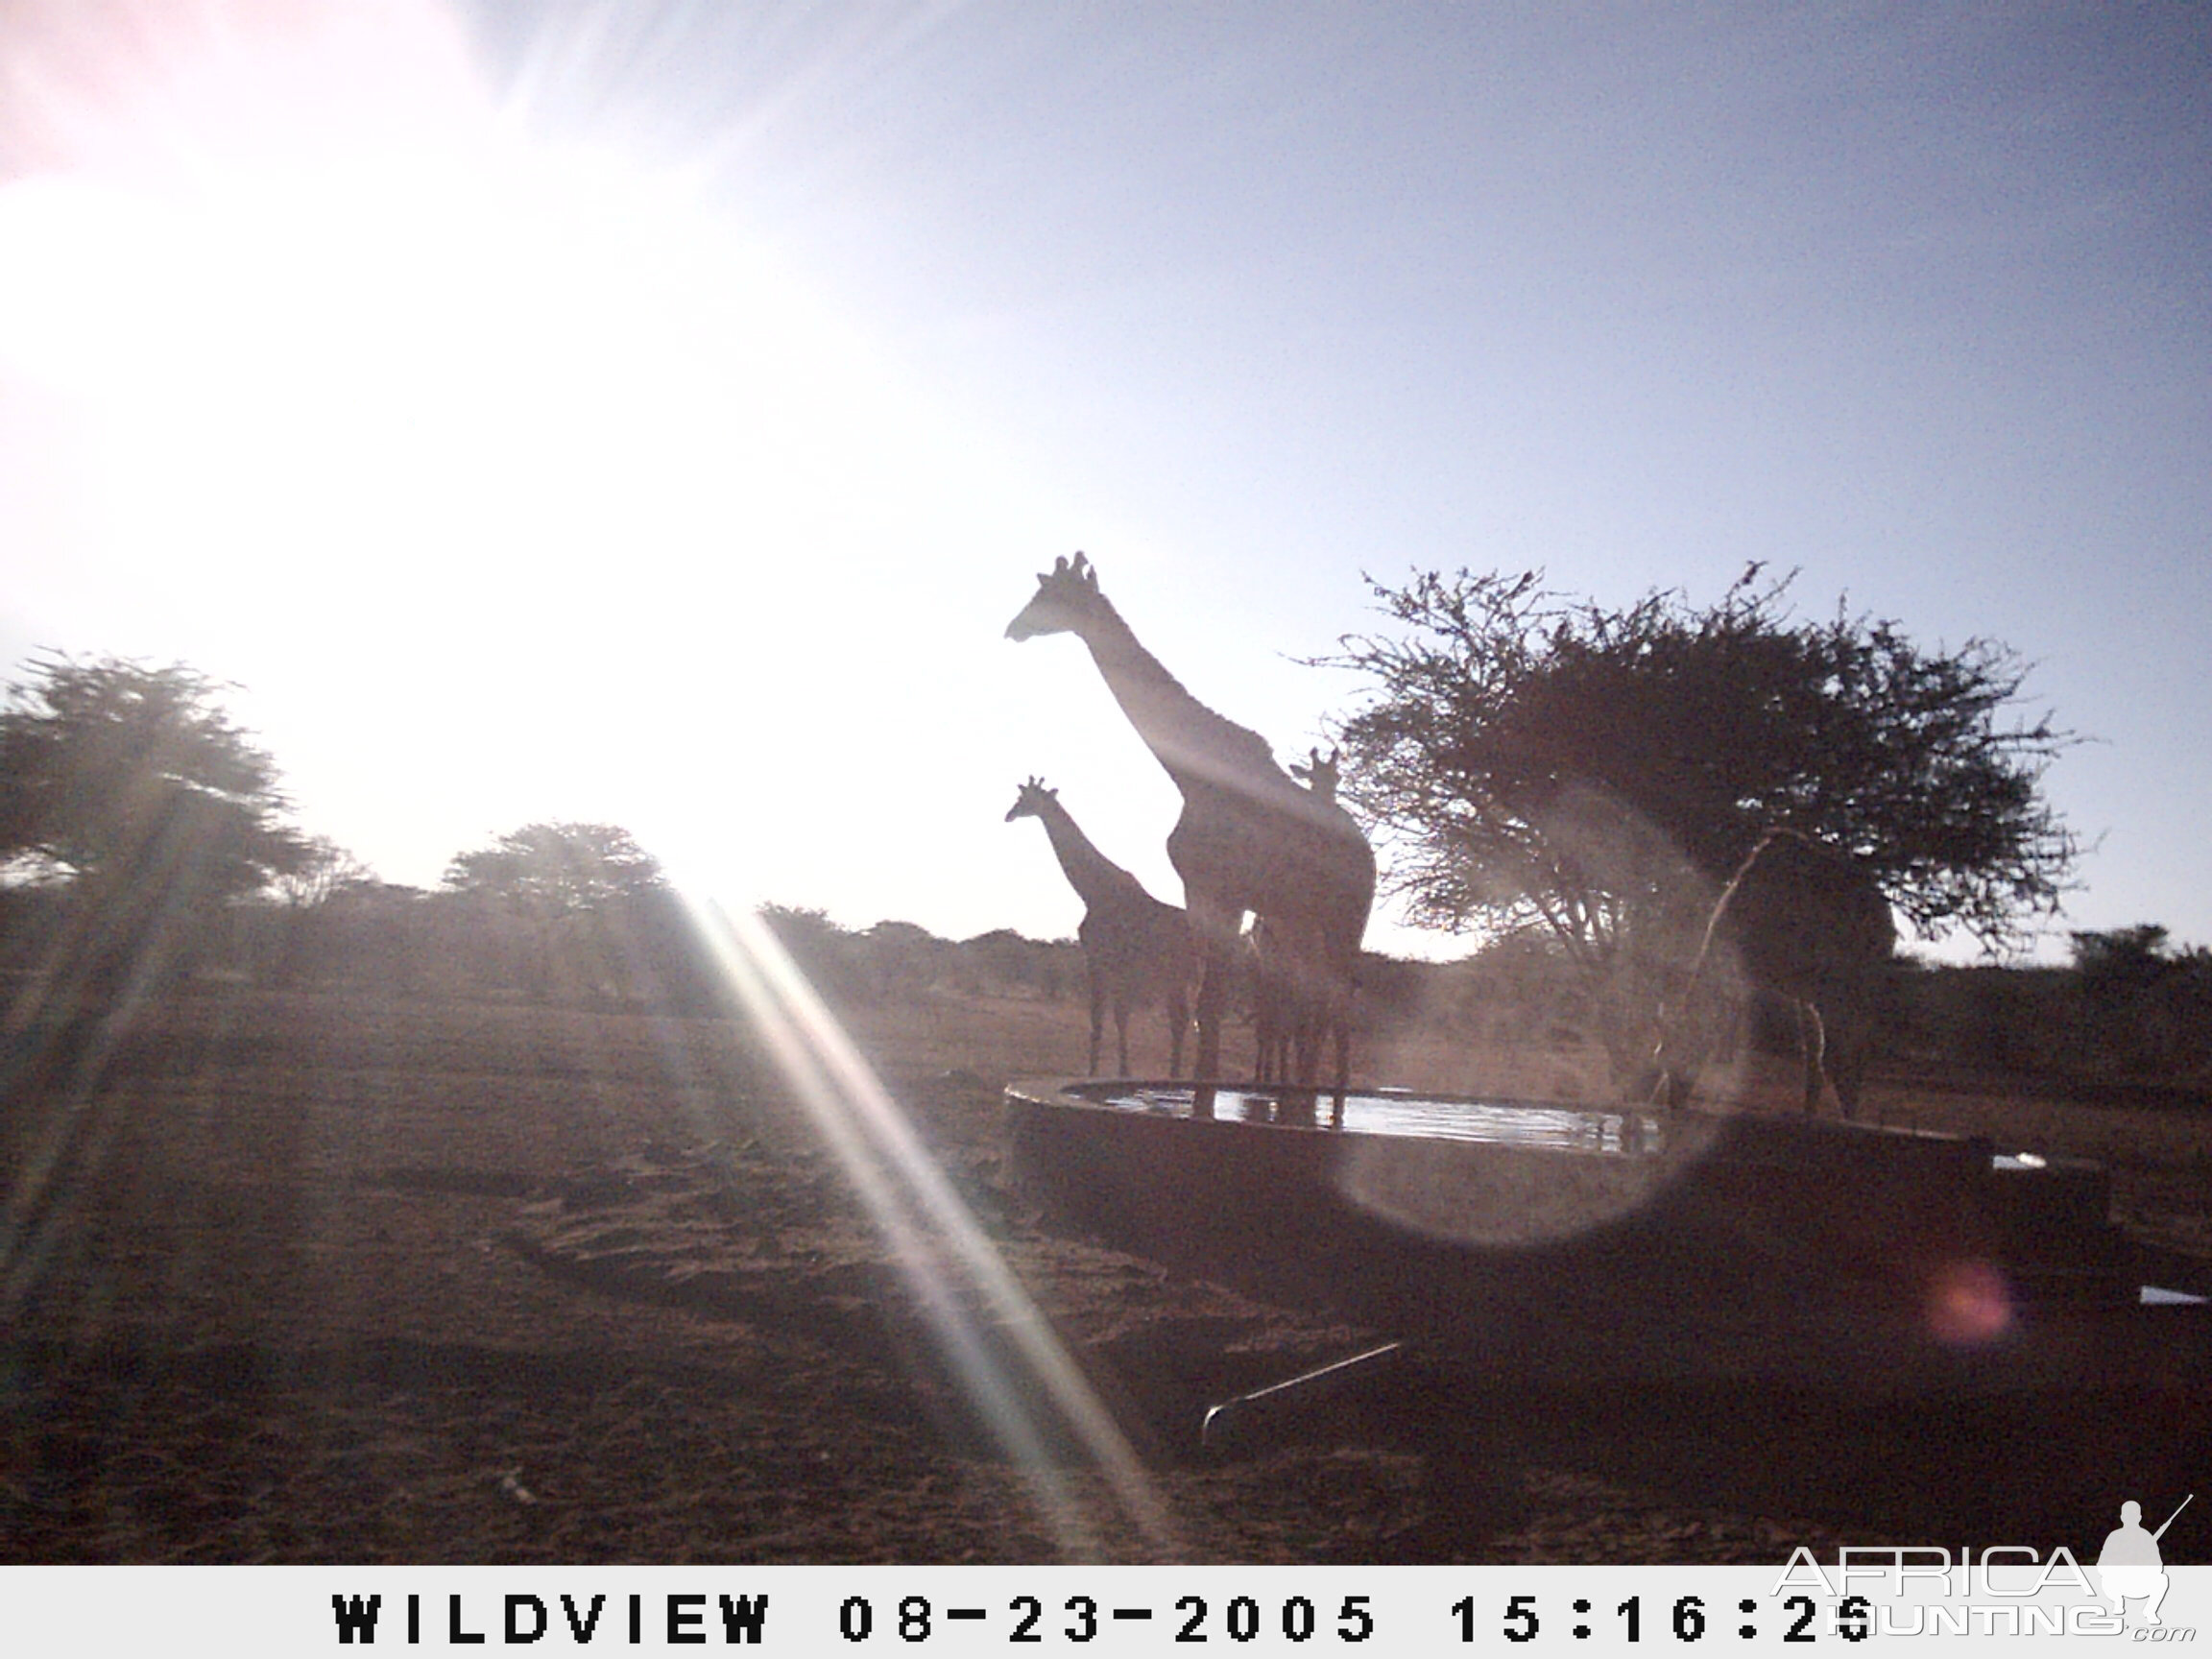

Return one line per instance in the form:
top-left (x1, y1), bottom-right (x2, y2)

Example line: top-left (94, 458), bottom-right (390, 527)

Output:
top-left (0, 655), bottom-right (1082, 1028)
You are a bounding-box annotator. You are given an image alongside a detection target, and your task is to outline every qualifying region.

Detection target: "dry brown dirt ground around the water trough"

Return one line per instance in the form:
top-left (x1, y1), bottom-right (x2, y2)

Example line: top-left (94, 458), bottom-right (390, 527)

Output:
top-left (0, 993), bottom-right (2212, 1564)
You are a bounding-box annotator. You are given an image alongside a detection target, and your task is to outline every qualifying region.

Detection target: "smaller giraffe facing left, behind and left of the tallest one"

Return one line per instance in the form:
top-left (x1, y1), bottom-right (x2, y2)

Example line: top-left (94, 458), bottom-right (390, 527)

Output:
top-left (1006, 779), bottom-right (1196, 1077)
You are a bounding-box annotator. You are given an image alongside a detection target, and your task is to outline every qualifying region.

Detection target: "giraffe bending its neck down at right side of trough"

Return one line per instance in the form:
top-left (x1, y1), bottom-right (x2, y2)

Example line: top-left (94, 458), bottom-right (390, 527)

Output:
top-left (1647, 830), bottom-right (1898, 1119)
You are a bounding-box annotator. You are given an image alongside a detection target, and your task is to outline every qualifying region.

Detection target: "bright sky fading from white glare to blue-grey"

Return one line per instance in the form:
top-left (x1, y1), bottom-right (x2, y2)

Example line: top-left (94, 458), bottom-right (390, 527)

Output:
top-left (0, 0), bottom-right (2212, 953)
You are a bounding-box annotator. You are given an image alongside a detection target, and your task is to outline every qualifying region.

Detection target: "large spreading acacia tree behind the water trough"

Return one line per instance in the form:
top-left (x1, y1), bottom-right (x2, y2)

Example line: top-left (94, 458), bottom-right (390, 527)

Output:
top-left (1325, 566), bottom-right (2077, 971)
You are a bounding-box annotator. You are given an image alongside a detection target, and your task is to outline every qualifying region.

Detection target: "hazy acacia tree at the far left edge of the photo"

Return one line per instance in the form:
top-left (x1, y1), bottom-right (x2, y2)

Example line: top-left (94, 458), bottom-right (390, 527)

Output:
top-left (0, 657), bottom-right (307, 1002)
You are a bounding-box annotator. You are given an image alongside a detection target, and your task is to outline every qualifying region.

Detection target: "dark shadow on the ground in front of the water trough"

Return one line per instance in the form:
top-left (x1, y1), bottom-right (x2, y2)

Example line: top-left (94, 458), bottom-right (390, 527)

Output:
top-left (1212, 1360), bottom-right (2212, 1566)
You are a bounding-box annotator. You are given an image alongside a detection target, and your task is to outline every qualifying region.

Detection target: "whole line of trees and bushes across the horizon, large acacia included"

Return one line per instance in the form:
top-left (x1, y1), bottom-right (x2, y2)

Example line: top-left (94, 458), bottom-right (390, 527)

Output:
top-left (0, 645), bottom-right (2212, 1086)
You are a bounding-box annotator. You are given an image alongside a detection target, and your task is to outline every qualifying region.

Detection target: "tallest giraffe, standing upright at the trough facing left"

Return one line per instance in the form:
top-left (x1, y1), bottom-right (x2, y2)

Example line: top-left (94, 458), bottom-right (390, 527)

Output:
top-left (1006, 553), bottom-right (1376, 1111)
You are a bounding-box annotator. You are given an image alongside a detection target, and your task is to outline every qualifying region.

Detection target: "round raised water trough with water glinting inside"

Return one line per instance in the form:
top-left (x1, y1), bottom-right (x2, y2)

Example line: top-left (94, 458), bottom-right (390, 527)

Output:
top-left (1006, 1079), bottom-right (2212, 1394)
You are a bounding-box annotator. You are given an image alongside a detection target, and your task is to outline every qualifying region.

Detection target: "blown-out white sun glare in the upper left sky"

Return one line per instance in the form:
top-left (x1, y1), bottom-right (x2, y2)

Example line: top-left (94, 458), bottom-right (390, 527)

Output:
top-left (0, 5), bottom-right (995, 911)
